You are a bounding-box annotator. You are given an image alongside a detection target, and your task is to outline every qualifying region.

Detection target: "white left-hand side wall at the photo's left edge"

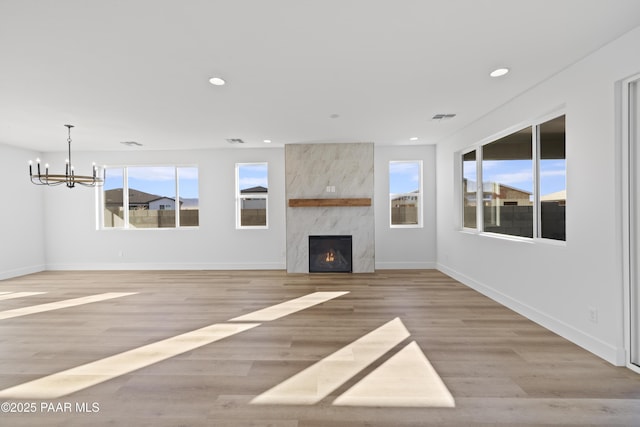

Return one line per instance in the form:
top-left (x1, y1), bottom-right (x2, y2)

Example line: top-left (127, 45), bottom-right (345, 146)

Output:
top-left (0, 144), bottom-right (45, 279)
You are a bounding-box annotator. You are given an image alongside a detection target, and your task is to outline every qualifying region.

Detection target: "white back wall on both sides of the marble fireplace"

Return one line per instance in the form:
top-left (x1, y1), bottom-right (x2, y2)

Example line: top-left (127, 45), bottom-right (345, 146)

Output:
top-left (25, 142), bottom-right (436, 275)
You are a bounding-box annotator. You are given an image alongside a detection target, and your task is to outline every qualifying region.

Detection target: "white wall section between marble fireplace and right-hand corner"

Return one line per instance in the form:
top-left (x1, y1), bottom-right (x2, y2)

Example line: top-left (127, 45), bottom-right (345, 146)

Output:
top-left (374, 145), bottom-right (436, 269)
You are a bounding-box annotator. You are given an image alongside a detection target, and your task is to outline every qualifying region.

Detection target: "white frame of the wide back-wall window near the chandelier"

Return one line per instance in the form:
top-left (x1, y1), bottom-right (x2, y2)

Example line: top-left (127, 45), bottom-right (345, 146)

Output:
top-left (96, 164), bottom-right (200, 231)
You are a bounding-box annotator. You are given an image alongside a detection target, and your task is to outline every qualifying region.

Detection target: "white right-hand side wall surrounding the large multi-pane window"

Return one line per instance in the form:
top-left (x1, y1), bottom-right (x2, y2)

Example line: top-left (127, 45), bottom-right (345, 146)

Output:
top-left (437, 25), bottom-right (640, 364)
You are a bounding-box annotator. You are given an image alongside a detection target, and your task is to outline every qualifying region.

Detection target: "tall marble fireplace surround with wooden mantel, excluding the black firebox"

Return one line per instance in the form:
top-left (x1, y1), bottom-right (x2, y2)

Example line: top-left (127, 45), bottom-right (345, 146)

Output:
top-left (285, 143), bottom-right (375, 273)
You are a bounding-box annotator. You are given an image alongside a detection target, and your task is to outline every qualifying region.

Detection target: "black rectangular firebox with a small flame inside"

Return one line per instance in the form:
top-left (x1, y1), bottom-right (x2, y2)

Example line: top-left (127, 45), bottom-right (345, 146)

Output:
top-left (309, 236), bottom-right (353, 273)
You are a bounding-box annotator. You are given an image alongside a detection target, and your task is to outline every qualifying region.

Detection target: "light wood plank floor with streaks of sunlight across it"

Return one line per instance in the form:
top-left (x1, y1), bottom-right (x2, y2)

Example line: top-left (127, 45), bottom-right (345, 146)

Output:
top-left (0, 270), bottom-right (640, 427)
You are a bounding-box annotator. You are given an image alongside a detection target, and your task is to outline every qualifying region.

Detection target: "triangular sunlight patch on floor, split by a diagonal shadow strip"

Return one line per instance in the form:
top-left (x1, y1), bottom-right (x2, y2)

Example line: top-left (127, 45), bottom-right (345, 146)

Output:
top-left (251, 318), bottom-right (455, 407)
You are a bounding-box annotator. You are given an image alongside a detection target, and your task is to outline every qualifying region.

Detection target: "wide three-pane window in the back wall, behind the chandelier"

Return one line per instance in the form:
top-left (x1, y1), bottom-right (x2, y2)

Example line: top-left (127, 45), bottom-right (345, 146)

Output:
top-left (103, 166), bottom-right (199, 229)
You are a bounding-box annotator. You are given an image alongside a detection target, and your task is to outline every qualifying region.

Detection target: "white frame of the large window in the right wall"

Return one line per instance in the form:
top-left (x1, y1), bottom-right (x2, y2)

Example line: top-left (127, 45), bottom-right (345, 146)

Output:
top-left (457, 108), bottom-right (568, 246)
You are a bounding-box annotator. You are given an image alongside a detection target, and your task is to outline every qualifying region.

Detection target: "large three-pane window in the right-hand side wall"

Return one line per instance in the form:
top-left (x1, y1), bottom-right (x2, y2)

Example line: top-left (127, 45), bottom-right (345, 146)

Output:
top-left (462, 116), bottom-right (566, 240)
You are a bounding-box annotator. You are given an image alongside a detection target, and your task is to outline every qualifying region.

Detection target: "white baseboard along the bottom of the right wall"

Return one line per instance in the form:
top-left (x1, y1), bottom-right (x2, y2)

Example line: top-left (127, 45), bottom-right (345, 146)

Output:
top-left (436, 263), bottom-right (625, 366)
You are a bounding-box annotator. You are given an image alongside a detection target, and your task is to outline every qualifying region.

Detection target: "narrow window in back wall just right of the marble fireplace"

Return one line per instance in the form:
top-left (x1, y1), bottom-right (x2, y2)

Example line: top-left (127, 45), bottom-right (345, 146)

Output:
top-left (389, 160), bottom-right (422, 227)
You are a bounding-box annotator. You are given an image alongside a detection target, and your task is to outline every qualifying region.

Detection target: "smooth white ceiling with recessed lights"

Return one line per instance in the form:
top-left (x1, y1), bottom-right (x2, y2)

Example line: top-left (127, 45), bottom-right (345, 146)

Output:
top-left (0, 0), bottom-right (640, 151)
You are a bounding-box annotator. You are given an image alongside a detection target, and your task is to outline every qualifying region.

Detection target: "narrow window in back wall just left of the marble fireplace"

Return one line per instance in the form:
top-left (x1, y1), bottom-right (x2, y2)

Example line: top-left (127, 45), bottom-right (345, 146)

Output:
top-left (236, 163), bottom-right (269, 228)
